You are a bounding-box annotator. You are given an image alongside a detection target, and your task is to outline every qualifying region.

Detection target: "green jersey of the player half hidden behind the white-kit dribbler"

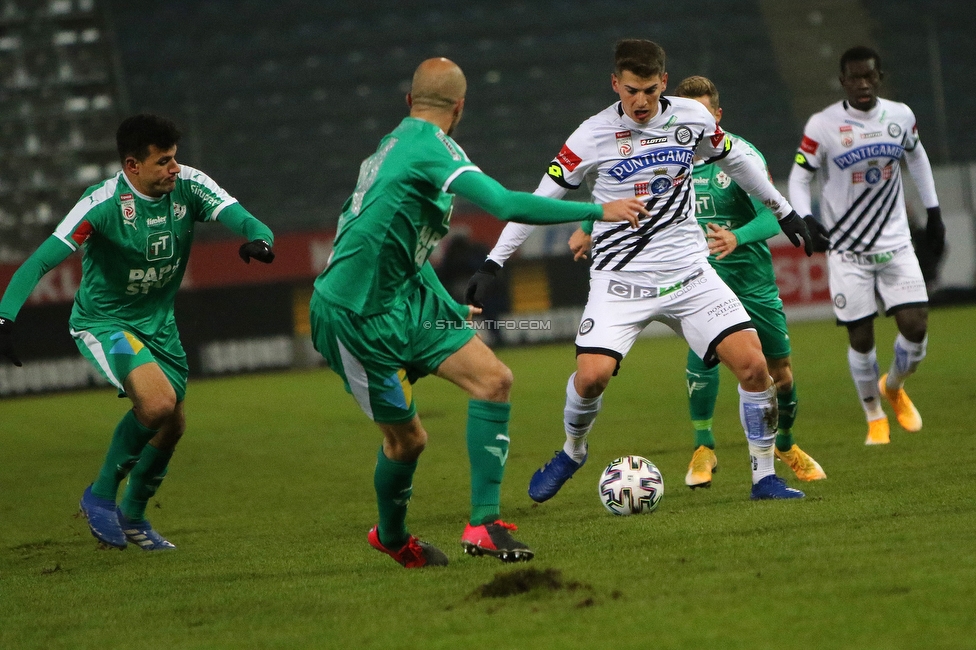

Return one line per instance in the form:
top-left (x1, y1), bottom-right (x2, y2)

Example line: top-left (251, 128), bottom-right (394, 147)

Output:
top-left (692, 132), bottom-right (779, 297)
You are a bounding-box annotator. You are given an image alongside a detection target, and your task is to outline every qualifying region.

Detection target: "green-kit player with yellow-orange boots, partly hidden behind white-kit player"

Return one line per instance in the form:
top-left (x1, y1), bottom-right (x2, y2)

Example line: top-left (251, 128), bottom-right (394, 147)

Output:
top-left (675, 76), bottom-right (827, 489)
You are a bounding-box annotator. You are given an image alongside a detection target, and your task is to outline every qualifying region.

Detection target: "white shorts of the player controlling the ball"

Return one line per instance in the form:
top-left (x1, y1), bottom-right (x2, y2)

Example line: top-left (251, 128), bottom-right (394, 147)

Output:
top-left (576, 264), bottom-right (754, 367)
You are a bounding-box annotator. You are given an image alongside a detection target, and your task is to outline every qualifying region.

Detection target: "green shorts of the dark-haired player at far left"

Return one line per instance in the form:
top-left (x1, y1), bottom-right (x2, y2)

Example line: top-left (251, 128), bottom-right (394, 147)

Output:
top-left (71, 322), bottom-right (189, 402)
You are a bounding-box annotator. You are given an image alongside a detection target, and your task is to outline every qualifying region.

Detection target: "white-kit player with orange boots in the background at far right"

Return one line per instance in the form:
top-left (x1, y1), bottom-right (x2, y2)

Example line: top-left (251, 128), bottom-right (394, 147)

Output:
top-left (790, 46), bottom-right (945, 445)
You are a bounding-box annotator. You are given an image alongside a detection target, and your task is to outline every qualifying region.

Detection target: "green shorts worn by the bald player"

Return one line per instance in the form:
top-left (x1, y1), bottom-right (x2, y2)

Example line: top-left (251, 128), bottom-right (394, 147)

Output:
top-left (311, 286), bottom-right (475, 424)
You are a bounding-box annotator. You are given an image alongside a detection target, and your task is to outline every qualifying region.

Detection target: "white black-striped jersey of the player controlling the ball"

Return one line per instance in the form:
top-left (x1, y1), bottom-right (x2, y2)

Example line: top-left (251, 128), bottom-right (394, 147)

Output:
top-left (488, 97), bottom-right (790, 285)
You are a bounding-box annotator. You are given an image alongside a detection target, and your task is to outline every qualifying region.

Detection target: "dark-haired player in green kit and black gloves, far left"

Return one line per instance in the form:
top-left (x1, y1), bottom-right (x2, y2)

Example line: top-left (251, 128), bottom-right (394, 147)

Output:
top-left (0, 115), bottom-right (274, 551)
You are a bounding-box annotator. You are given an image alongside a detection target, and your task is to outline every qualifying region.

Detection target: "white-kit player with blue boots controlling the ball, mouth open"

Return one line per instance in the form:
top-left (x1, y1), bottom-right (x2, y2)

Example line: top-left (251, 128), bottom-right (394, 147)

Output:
top-left (466, 39), bottom-right (819, 502)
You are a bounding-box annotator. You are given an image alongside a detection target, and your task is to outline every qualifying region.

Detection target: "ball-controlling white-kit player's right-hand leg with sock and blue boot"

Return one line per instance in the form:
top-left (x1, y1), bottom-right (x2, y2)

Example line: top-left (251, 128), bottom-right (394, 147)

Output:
top-left (715, 330), bottom-right (804, 499)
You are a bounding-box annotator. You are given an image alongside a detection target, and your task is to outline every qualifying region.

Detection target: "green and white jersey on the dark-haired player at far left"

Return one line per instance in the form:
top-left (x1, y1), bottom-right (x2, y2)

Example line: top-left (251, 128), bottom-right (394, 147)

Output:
top-left (47, 166), bottom-right (262, 337)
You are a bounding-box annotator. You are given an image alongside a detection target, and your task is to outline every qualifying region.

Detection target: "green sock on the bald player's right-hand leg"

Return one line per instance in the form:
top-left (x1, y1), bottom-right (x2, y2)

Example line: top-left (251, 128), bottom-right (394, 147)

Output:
top-left (467, 399), bottom-right (512, 526)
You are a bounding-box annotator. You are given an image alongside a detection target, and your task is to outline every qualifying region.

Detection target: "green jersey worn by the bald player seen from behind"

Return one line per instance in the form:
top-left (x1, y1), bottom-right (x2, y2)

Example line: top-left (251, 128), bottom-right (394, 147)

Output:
top-left (315, 117), bottom-right (481, 316)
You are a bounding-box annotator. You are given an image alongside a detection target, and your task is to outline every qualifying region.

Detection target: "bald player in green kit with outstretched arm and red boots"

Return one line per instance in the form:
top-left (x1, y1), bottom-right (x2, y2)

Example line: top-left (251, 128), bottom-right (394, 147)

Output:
top-left (311, 58), bottom-right (646, 568)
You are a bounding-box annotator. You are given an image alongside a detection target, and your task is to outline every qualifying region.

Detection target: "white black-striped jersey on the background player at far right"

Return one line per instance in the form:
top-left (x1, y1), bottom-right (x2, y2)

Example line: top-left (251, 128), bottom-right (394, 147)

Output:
top-left (790, 98), bottom-right (938, 253)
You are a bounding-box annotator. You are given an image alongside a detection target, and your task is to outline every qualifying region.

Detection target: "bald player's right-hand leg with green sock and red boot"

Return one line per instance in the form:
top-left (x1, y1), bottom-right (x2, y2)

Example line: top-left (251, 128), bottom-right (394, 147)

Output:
top-left (437, 337), bottom-right (533, 562)
